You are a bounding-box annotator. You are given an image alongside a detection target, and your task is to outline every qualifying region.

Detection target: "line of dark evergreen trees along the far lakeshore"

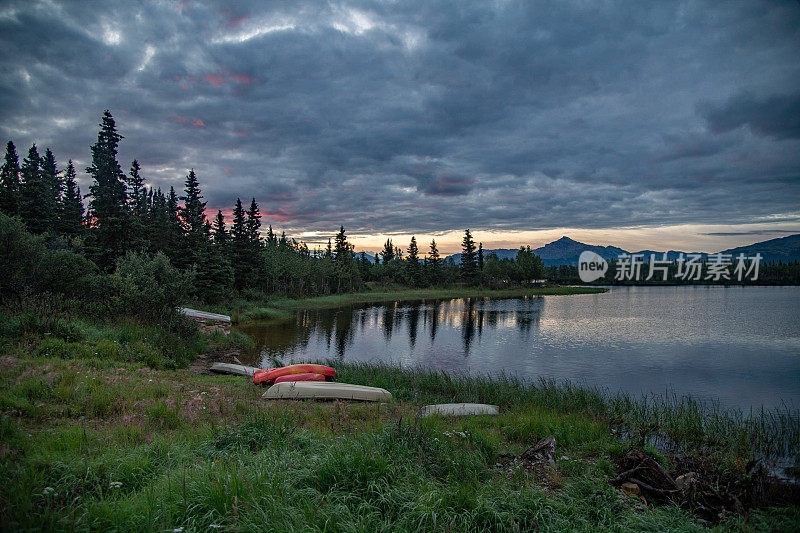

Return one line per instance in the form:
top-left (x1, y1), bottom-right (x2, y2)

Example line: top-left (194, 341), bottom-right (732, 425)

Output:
top-left (0, 111), bottom-right (544, 301)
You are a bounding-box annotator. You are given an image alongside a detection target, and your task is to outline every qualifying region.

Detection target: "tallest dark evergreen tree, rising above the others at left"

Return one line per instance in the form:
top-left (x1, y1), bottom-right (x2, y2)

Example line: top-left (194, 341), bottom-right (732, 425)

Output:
top-left (86, 110), bottom-right (130, 270)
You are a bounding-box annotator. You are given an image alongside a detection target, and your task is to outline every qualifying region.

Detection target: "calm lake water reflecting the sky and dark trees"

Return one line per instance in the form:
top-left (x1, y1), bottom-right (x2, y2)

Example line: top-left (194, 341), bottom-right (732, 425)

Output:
top-left (242, 287), bottom-right (800, 409)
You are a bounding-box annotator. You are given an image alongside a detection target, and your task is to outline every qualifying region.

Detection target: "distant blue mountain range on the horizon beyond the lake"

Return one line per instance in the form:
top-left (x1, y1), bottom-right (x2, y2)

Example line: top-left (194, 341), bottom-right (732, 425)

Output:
top-left (448, 234), bottom-right (800, 266)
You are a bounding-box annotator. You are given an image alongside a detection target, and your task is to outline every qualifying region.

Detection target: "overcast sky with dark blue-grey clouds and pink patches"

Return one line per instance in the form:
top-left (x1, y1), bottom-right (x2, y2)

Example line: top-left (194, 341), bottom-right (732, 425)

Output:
top-left (0, 0), bottom-right (800, 254)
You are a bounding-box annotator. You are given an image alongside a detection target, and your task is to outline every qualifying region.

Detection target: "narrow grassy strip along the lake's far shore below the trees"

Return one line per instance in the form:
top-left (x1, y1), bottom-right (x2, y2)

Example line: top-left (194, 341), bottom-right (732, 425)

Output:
top-left (215, 287), bottom-right (607, 322)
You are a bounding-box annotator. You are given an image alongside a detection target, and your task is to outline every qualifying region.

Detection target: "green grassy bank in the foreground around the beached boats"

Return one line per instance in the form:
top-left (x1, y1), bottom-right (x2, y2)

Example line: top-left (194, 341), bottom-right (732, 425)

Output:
top-left (0, 352), bottom-right (800, 531)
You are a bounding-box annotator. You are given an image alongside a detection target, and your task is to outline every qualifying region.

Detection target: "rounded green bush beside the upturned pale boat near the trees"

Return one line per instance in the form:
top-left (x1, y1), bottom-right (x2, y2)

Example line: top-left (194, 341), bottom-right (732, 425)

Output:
top-left (114, 252), bottom-right (194, 323)
